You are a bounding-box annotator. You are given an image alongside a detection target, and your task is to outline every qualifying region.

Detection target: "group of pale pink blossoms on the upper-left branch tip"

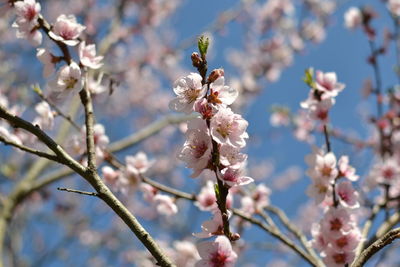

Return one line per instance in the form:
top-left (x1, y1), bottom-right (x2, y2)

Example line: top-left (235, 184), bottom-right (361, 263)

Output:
top-left (13, 3), bottom-right (103, 97)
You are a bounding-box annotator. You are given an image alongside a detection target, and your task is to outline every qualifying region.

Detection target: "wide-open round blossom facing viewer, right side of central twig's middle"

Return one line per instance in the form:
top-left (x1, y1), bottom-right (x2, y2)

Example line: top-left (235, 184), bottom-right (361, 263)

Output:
top-left (210, 107), bottom-right (249, 148)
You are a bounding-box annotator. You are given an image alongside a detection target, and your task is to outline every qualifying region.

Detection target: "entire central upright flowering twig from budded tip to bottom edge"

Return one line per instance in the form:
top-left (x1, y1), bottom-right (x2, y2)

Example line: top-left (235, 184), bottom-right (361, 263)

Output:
top-left (169, 50), bottom-right (253, 266)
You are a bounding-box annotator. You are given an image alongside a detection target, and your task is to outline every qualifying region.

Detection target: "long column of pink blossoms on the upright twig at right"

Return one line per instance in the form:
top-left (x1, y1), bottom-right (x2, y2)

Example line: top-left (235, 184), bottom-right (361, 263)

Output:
top-left (301, 69), bottom-right (361, 266)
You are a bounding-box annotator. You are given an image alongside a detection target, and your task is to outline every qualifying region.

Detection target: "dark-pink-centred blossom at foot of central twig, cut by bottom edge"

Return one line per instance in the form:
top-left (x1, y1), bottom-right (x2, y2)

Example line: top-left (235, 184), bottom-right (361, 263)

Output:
top-left (196, 236), bottom-right (237, 267)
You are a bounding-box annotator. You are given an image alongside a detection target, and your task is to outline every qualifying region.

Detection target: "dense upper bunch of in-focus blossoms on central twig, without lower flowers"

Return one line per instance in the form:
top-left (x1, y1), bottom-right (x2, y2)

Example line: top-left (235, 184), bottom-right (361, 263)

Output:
top-left (170, 69), bottom-right (252, 187)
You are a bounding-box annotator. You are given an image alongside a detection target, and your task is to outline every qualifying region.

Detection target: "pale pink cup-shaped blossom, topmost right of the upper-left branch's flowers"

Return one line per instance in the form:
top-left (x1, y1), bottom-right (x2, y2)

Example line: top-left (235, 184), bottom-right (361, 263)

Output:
top-left (49, 14), bottom-right (86, 46)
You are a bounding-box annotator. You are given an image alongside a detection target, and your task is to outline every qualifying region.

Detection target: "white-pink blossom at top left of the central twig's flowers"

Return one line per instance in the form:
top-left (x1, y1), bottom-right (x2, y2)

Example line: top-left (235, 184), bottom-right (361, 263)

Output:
top-left (169, 72), bottom-right (207, 114)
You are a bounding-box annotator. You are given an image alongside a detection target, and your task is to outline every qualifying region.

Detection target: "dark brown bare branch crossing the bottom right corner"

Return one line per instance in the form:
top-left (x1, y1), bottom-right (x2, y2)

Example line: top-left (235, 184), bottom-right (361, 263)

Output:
top-left (351, 228), bottom-right (400, 267)
